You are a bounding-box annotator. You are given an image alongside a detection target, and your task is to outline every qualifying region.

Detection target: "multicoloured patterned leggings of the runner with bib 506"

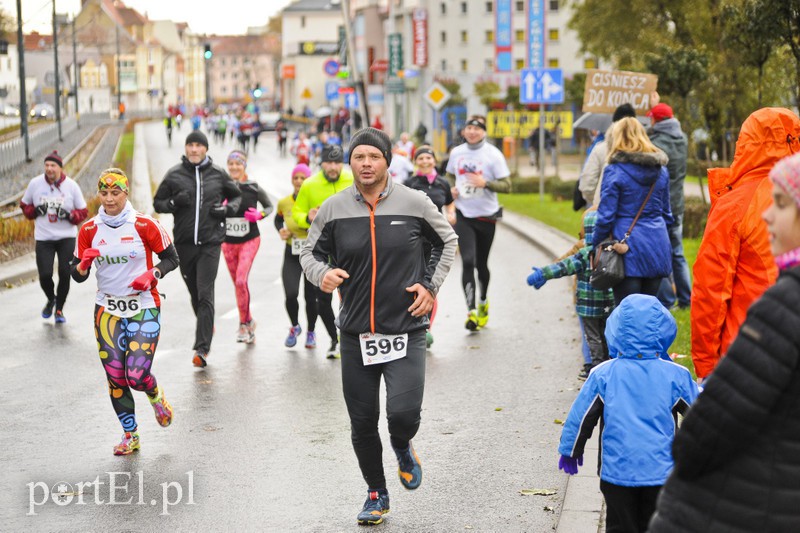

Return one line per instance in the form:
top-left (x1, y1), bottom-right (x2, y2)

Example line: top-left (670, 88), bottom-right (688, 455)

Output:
top-left (94, 305), bottom-right (161, 431)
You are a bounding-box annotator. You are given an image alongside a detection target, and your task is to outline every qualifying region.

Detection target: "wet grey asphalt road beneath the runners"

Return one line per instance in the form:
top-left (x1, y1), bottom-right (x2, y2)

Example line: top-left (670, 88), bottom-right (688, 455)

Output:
top-left (0, 124), bottom-right (581, 532)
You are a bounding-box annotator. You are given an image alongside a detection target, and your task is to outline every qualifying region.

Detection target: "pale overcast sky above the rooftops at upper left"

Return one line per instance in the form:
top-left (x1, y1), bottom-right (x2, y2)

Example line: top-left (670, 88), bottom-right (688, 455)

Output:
top-left (0, 0), bottom-right (291, 35)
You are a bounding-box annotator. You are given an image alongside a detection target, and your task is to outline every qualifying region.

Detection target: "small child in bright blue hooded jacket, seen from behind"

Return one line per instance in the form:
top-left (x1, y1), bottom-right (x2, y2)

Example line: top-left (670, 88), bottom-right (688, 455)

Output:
top-left (558, 294), bottom-right (698, 533)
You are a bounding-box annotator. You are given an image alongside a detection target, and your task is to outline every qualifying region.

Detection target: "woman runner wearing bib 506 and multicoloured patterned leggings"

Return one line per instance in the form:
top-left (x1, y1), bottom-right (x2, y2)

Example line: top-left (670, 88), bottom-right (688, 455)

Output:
top-left (70, 168), bottom-right (178, 455)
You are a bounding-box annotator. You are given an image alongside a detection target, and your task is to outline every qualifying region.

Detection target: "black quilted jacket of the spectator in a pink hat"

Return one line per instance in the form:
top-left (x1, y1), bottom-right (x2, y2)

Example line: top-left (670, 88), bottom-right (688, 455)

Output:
top-left (649, 267), bottom-right (800, 533)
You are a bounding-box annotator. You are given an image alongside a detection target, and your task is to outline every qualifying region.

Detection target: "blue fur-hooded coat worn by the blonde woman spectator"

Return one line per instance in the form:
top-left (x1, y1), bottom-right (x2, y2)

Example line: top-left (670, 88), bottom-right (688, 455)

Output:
top-left (594, 150), bottom-right (674, 278)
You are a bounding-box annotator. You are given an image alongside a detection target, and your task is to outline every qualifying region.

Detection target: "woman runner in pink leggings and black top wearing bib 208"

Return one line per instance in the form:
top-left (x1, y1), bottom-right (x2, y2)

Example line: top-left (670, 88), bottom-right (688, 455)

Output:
top-left (222, 150), bottom-right (272, 344)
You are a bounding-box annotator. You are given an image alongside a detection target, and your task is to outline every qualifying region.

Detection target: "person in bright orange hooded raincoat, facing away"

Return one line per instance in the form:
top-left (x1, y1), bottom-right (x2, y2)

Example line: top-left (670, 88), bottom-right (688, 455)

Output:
top-left (691, 107), bottom-right (800, 379)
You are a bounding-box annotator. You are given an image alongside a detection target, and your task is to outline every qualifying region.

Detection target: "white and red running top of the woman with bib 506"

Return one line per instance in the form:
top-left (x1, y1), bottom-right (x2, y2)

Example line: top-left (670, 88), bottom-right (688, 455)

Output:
top-left (75, 211), bottom-right (172, 309)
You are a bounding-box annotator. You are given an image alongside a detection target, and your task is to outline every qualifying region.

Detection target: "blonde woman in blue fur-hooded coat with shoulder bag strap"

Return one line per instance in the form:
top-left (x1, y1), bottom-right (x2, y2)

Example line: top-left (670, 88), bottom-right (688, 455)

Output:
top-left (593, 117), bottom-right (673, 305)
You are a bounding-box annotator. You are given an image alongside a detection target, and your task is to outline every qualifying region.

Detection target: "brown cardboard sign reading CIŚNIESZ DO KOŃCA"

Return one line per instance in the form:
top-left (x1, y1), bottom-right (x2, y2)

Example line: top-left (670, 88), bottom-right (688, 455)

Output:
top-left (583, 69), bottom-right (658, 115)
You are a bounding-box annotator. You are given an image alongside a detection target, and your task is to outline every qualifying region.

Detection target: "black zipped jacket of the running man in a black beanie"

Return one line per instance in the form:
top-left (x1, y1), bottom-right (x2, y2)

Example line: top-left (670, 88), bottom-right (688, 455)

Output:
top-left (153, 156), bottom-right (242, 245)
